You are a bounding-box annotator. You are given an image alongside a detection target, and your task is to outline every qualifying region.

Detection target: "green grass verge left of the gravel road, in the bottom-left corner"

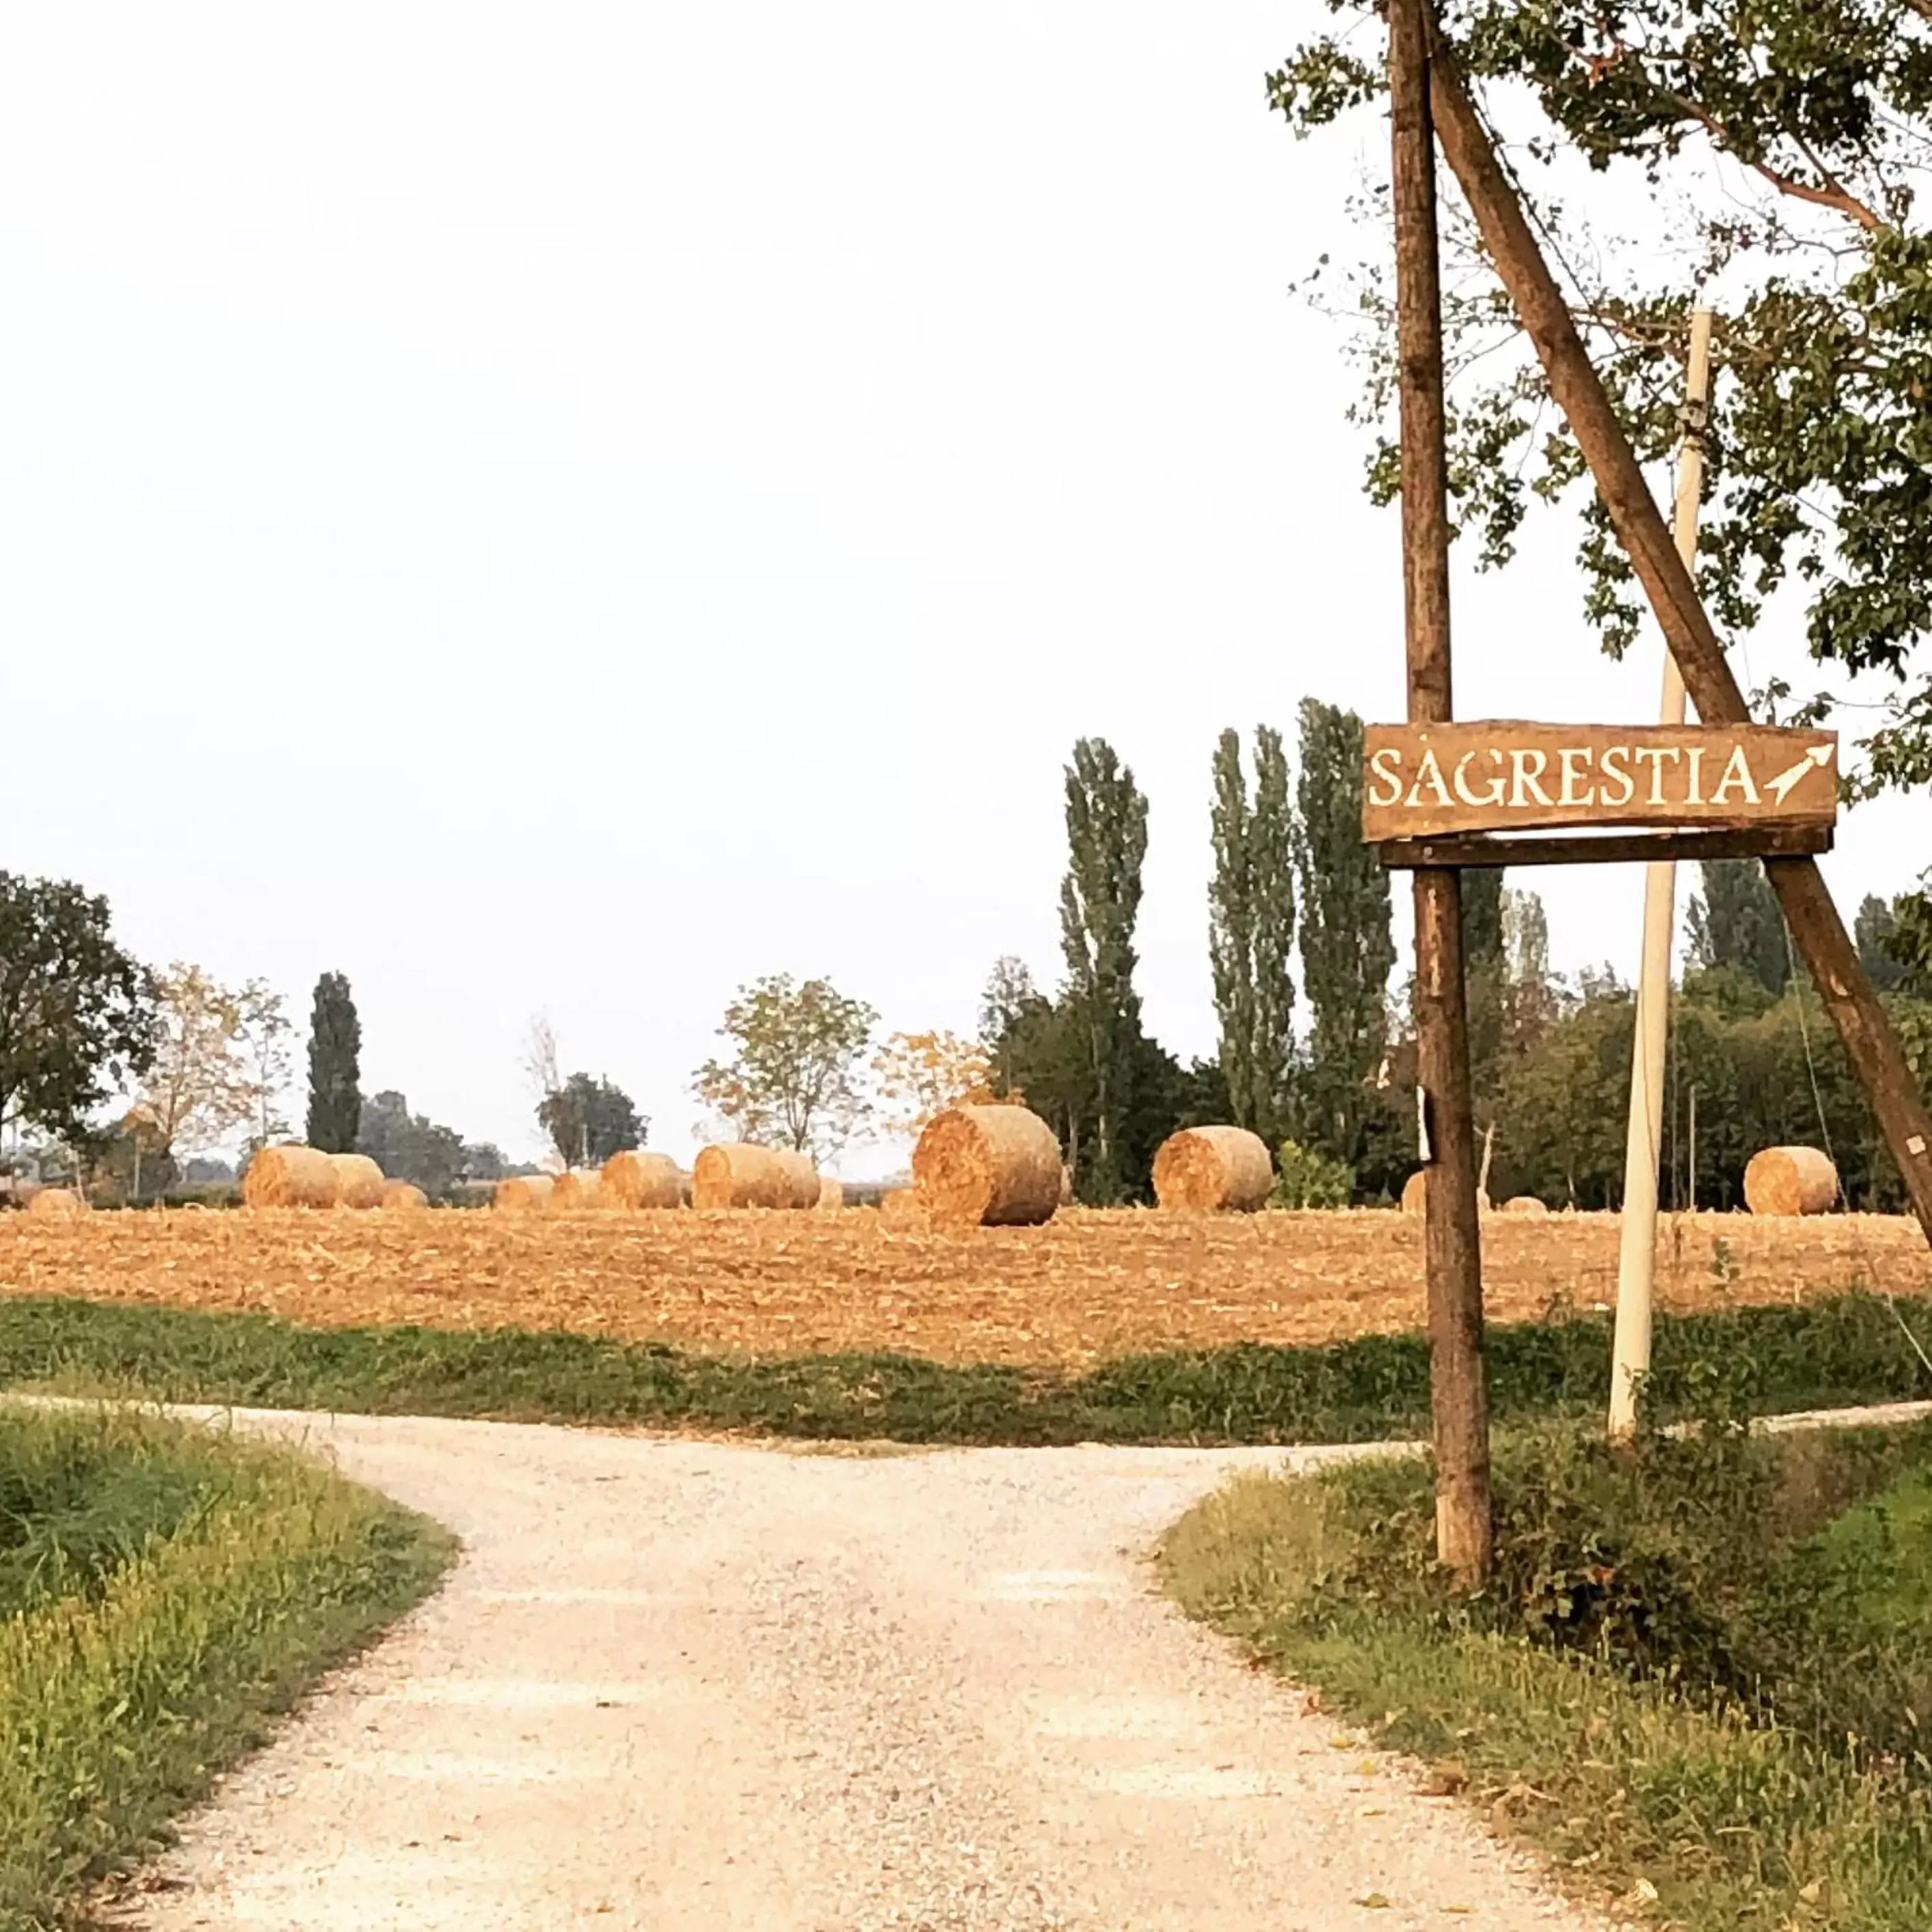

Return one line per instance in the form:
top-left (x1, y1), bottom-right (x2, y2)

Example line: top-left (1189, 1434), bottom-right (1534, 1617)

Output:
top-left (0, 1409), bottom-right (452, 1932)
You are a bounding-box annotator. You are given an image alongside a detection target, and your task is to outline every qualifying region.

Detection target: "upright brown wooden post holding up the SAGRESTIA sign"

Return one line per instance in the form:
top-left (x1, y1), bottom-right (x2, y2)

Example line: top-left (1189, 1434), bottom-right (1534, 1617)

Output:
top-left (1389, 0), bottom-right (1493, 1588)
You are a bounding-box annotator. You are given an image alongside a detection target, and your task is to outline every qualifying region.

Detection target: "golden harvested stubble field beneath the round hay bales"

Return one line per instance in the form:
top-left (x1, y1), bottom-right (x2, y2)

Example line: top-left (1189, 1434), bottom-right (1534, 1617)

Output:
top-left (0, 1207), bottom-right (1932, 1368)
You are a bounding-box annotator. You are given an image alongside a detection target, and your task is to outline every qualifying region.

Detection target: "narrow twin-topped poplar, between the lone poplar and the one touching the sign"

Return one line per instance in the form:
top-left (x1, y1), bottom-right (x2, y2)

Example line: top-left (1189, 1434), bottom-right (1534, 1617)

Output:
top-left (1207, 725), bottom-right (1295, 1144)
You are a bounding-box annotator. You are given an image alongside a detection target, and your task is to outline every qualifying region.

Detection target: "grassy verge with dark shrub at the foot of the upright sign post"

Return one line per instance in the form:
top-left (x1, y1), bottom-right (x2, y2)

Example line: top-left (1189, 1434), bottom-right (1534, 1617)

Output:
top-left (1161, 1424), bottom-right (1932, 1932)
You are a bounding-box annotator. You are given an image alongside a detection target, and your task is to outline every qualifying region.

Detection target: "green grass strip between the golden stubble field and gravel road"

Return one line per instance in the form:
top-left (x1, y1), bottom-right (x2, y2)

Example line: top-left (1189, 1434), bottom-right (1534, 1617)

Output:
top-left (0, 1295), bottom-right (1932, 1443)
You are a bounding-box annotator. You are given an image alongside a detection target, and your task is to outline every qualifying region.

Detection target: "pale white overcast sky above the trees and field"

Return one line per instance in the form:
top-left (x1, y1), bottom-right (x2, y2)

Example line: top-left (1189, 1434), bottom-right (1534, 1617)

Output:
top-left (0, 0), bottom-right (1932, 1174)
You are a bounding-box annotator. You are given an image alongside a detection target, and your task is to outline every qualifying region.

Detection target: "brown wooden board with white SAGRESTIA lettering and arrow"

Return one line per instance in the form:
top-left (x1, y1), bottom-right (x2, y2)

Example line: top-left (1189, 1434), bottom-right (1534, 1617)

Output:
top-left (1362, 723), bottom-right (1837, 844)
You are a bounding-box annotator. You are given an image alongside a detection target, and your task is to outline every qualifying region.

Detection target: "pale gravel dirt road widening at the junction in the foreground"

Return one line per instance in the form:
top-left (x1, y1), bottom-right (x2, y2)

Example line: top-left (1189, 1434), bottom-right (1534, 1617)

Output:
top-left (118, 1418), bottom-right (1586, 1932)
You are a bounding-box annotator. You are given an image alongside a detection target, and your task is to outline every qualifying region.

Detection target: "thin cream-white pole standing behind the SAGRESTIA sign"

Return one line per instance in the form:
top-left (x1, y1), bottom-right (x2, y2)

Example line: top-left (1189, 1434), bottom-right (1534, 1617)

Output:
top-left (1609, 309), bottom-right (1712, 1441)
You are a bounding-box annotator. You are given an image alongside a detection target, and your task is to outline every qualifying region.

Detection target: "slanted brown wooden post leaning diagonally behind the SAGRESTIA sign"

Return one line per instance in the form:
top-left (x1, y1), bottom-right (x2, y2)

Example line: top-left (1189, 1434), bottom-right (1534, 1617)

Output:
top-left (1428, 48), bottom-right (1932, 1241)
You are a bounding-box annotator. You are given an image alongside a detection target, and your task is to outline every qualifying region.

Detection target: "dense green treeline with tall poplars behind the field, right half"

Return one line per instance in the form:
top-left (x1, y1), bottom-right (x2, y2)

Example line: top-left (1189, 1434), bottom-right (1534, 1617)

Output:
top-left (979, 697), bottom-right (1932, 1211)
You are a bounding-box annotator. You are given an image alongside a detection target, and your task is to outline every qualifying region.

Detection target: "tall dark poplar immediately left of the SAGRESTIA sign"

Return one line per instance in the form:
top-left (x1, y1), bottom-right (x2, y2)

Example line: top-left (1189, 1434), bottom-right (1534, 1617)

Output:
top-left (1295, 697), bottom-right (1398, 1167)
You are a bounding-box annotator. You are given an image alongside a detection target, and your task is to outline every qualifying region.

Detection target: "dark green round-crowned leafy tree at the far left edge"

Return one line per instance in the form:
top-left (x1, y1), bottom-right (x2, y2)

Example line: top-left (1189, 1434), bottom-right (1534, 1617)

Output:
top-left (0, 871), bottom-right (154, 1138)
